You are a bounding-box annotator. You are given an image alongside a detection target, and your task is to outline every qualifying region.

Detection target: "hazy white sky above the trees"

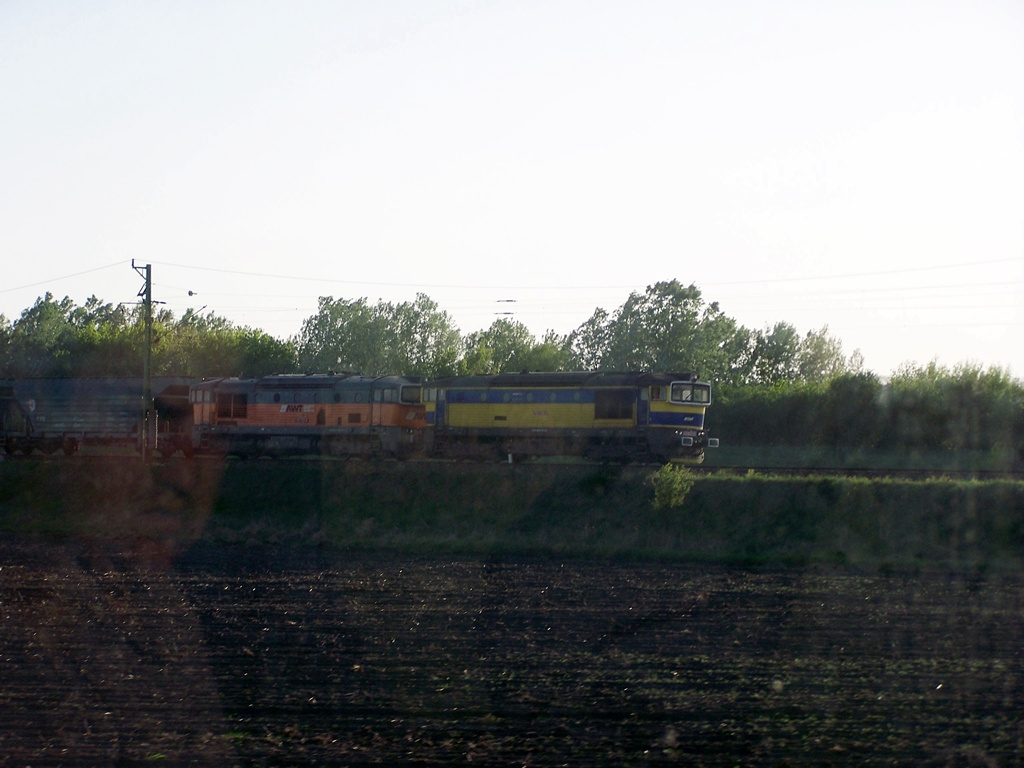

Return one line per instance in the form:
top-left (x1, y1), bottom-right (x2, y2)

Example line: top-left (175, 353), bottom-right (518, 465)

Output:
top-left (0, 0), bottom-right (1024, 377)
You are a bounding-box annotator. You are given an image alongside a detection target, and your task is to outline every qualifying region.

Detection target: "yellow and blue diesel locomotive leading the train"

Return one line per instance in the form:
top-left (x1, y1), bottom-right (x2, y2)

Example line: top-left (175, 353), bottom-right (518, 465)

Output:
top-left (426, 372), bottom-right (718, 464)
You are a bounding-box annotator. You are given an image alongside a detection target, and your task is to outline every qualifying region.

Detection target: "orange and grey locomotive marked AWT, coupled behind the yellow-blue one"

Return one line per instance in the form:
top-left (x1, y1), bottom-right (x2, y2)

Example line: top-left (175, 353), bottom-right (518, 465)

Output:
top-left (189, 374), bottom-right (427, 458)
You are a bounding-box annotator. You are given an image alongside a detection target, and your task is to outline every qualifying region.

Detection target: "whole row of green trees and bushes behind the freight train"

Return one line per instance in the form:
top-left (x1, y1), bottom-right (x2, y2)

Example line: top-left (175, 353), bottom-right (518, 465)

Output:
top-left (0, 281), bottom-right (1024, 460)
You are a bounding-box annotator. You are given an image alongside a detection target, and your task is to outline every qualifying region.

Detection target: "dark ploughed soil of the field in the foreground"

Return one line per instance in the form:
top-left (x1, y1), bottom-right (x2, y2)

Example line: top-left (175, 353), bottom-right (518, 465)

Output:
top-left (0, 537), bottom-right (1024, 766)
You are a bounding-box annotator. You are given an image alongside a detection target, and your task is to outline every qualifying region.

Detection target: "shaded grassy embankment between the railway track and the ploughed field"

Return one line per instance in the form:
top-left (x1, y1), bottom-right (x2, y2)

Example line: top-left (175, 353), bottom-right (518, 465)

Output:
top-left (0, 460), bottom-right (1024, 568)
